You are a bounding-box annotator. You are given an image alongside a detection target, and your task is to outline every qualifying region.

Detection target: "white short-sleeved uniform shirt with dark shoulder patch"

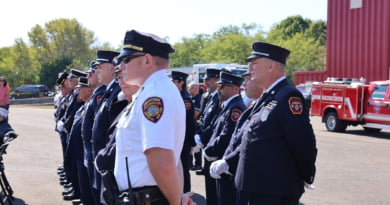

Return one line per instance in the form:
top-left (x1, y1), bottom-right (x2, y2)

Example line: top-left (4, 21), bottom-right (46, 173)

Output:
top-left (114, 70), bottom-right (186, 191)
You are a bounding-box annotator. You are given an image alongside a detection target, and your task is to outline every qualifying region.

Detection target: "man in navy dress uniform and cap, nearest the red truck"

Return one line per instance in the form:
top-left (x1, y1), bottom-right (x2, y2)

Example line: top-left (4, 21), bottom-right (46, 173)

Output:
top-left (235, 42), bottom-right (317, 205)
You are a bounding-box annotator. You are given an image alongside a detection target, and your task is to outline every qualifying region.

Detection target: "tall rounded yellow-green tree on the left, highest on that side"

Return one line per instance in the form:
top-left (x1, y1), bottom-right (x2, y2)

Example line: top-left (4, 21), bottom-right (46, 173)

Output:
top-left (28, 19), bottom-right (97, 87)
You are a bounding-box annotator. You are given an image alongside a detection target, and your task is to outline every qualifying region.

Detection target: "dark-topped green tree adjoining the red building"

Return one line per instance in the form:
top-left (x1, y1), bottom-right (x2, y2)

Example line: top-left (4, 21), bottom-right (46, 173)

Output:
top-left (265, 16), bottom-right (326, 82)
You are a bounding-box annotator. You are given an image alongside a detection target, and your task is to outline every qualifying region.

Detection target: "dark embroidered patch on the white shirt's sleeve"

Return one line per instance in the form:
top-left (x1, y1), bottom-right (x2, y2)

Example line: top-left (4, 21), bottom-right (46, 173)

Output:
top-left (142, 97), bottom-right (164, 123)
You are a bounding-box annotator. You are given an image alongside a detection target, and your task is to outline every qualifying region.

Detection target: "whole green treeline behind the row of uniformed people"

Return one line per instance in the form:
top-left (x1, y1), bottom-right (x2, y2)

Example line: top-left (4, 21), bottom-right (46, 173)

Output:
top-left (0, 16), bottom-right (326, 87)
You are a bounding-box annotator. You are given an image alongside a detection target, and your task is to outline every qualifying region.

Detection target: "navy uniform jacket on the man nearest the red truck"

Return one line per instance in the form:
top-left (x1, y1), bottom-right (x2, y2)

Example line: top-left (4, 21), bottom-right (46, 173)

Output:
top-left (235, 79), bottom-right (317, 196)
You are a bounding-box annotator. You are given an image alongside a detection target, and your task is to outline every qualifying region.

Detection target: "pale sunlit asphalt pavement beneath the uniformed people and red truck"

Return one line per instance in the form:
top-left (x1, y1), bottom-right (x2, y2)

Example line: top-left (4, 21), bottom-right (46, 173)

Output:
top-left (3, 106), bottom-right (390, 205)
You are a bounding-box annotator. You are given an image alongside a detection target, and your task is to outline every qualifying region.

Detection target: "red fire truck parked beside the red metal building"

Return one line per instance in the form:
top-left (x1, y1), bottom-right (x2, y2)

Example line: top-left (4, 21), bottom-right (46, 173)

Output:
top-left (310, 78), bottom-right (390, 132)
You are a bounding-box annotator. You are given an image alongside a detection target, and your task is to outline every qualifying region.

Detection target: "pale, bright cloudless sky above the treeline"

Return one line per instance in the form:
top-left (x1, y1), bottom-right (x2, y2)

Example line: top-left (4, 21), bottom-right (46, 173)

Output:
top-left (0, 0), bottom-right (327, 47)
